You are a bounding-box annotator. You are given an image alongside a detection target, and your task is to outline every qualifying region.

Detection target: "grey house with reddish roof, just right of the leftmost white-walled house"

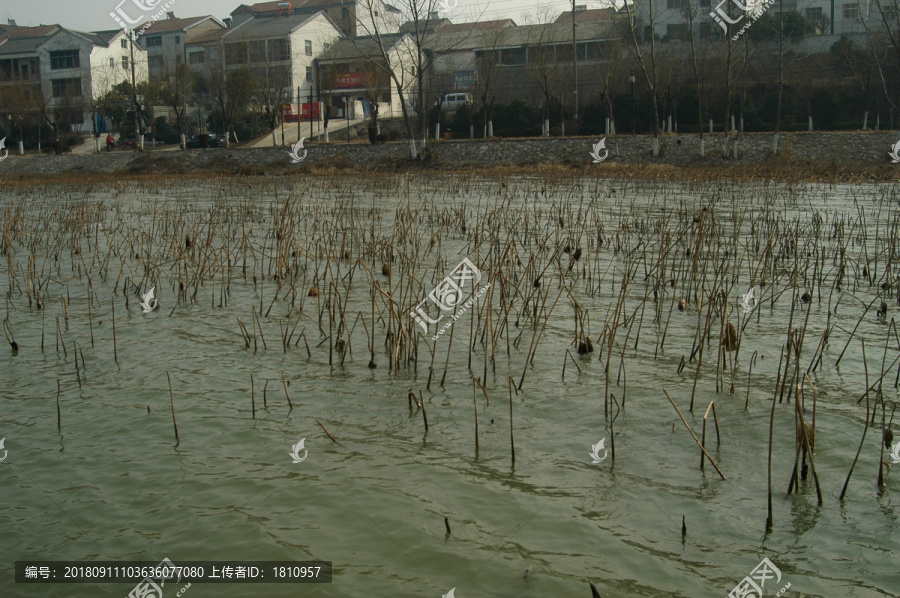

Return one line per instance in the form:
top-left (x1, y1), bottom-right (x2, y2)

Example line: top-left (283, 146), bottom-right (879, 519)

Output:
top-left (136, 12), bottom-right (227, 81)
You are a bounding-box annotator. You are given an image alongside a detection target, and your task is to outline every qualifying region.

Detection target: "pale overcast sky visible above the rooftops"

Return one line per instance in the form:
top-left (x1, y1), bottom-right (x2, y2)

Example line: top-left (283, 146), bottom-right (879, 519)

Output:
top-left (0, 0), bottom-right (607, 31)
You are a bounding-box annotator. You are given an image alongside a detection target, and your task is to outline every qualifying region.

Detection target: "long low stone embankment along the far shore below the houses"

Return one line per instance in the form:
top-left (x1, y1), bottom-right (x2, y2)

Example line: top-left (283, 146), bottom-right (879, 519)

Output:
top-left (0, 131), bottom-right (900, 181)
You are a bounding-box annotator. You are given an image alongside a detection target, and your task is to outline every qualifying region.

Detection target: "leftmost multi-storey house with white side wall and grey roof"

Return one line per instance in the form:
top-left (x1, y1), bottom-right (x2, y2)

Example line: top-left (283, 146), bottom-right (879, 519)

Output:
top-left (0, 25), bottom-right (147, 133)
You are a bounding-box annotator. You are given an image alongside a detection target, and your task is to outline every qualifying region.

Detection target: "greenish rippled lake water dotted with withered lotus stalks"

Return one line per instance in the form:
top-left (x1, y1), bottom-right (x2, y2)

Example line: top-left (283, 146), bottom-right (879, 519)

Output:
top-left (0, 176), bottom-right (900, 598)
